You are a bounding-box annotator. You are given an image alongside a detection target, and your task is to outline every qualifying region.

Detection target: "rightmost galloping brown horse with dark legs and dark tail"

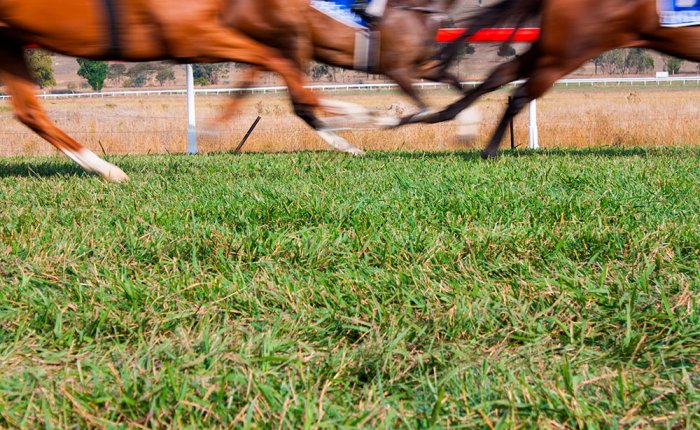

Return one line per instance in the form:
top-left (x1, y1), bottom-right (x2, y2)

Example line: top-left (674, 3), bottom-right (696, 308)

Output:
top-left (404, 0), bottom-right (700, 158)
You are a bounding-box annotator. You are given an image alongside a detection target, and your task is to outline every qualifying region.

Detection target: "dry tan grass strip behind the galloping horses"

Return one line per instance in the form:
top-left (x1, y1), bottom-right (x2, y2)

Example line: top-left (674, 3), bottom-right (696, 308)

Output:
top-left (0, 88), bottom-right (700, 156)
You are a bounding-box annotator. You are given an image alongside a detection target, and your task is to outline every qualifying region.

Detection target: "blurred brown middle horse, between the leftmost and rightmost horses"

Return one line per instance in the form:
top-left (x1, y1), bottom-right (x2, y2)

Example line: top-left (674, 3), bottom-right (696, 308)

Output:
top-left (217, 0), bottom-right (462, 127)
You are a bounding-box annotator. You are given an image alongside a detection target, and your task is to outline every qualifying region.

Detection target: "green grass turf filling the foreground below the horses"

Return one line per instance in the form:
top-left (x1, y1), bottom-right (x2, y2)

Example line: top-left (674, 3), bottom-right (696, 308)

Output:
top-left (0, 148), bottom-right (700, 429)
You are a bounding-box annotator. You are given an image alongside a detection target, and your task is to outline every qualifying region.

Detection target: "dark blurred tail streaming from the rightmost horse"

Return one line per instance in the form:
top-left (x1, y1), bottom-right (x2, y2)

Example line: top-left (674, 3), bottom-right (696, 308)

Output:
top-left (436, 0), bottom-right (544, 70)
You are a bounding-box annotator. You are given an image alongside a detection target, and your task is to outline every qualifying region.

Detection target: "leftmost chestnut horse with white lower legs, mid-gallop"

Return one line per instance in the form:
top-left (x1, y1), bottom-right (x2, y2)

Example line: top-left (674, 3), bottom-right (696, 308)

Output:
top-left (0, 0), bottom-right (366, 181)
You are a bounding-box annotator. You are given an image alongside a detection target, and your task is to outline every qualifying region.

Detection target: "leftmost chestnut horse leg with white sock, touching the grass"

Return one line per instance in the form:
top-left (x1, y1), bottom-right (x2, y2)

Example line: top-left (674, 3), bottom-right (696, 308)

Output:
top-left (0, 40), bottom-right (129, 182)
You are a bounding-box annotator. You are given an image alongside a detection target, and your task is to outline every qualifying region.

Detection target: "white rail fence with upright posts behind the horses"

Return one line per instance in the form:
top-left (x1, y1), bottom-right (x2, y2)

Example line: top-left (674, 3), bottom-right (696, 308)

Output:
top-left (0, 74), bottom-right (700, 154)
